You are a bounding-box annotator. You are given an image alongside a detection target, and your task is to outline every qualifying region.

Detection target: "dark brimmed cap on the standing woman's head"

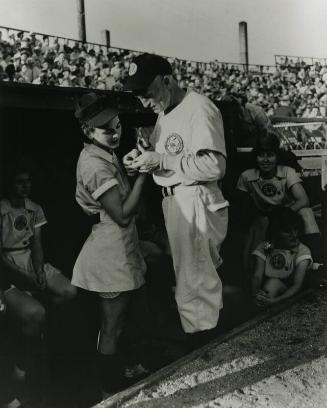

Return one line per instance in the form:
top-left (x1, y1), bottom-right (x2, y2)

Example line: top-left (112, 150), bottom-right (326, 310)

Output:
top-left (75, 92), bottom-right (118, 127)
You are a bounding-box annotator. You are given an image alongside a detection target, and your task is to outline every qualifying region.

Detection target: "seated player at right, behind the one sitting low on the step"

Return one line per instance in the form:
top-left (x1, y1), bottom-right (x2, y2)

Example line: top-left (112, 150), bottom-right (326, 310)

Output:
top-left (236, 129), bottom-right (322, 270)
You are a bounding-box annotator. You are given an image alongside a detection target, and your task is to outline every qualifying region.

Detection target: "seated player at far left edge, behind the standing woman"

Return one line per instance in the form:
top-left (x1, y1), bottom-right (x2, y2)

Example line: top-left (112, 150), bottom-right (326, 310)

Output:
top-left (0, 166), bottom-right (76, 392)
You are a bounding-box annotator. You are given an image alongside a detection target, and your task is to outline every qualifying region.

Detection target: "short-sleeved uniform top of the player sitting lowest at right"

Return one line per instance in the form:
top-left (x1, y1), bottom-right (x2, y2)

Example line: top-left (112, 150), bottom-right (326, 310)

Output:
top-left (252, 242), bottom-right (312, 284)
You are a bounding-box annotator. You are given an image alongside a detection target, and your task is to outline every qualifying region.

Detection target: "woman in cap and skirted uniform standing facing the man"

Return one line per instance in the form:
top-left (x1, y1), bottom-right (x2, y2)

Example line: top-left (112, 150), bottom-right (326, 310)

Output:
top-left (72, 93), bottom-right (146, 393)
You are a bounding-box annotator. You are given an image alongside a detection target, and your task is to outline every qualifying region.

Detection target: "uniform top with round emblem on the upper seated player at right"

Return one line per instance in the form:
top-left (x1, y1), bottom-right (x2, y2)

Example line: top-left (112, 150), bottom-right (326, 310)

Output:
top-left (236, 166), bottom-right (301, 212)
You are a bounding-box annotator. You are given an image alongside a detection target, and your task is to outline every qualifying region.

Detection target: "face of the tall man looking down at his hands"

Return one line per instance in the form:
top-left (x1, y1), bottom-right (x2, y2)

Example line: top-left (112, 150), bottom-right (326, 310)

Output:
top-left (138, 75), bottom-right (170, 113)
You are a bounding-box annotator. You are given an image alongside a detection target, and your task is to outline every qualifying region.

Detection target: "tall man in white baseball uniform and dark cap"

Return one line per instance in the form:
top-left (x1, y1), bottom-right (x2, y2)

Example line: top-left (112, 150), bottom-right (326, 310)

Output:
top-left (124, 54), bottom-right (228, 340)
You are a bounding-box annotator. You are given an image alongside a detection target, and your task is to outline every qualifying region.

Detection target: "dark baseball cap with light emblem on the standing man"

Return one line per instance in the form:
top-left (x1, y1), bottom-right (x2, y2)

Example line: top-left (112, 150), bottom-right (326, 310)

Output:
top-left (124, 53), bottom-right (172, 94)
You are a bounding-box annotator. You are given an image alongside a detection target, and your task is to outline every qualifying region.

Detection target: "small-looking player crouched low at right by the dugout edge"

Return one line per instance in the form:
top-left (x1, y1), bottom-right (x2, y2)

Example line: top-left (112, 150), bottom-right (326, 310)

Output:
top-left (252, 207), bottom-right (312, 306)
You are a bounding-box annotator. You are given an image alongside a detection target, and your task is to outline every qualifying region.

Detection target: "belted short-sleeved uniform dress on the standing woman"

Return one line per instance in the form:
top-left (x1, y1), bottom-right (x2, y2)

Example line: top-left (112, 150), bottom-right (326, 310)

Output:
top-left (72, 144), bottom-right (145, 292)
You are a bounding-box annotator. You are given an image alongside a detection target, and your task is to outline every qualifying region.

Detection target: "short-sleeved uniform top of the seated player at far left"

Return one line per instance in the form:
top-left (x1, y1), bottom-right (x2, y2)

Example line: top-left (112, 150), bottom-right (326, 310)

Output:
top-left (0, 198), bottom-right (47, 274)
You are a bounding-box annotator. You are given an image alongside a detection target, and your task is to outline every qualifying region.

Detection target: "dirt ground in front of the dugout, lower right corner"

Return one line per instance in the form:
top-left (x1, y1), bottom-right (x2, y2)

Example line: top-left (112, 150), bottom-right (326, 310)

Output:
top-left (102, 290), bottom-right (327, 408)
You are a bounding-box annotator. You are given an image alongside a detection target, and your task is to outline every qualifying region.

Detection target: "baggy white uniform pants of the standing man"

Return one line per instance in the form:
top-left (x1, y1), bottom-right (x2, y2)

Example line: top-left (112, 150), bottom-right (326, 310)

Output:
top-left (162, 183), bottom-right (228, 333)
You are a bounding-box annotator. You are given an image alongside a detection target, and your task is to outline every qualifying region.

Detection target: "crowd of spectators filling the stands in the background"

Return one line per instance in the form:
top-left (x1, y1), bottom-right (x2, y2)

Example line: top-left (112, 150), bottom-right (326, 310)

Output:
top-left (0, 28), bottom-right (327, 118)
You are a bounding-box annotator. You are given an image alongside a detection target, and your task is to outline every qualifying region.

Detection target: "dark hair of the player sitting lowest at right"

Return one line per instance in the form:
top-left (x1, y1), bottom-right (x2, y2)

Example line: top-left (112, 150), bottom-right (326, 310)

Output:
top-left (267, 207), bottom-right (303, 241)
